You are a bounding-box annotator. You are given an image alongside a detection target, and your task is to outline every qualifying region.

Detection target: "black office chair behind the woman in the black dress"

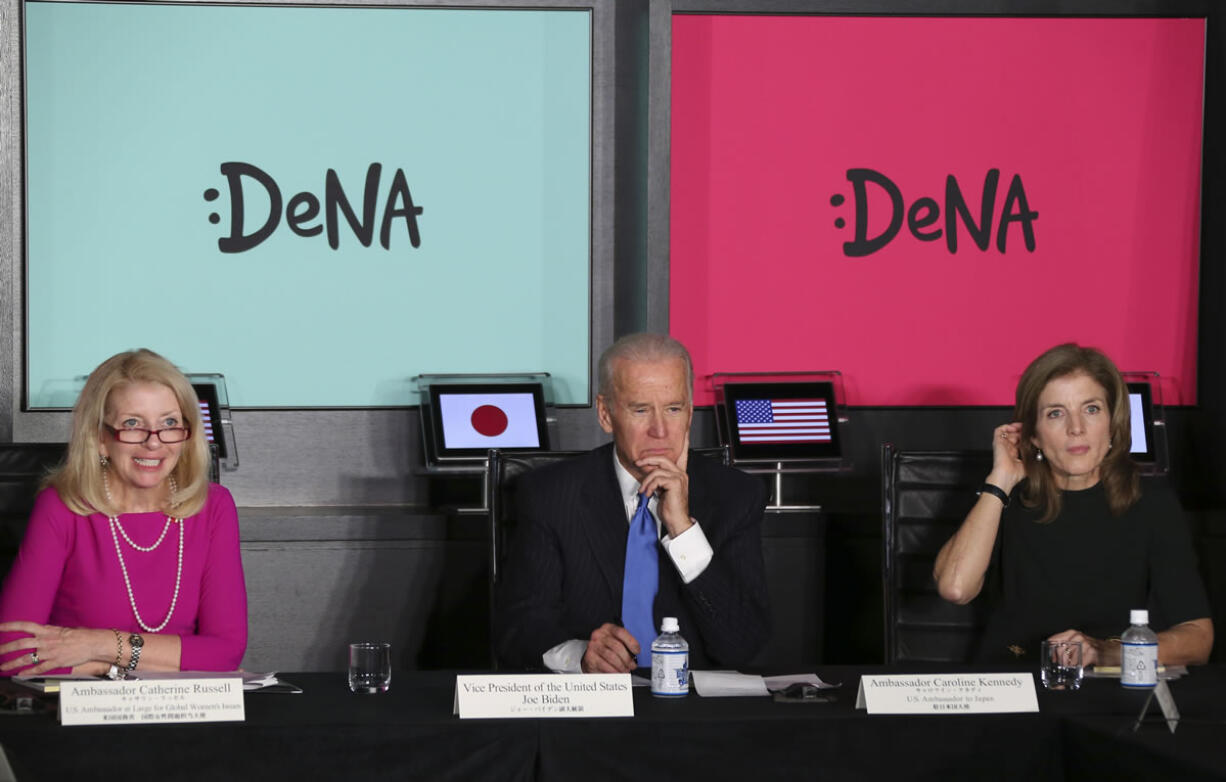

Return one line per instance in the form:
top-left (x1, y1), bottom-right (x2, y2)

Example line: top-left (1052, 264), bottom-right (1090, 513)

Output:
top-left (881, 442), bottom-right (992, 663)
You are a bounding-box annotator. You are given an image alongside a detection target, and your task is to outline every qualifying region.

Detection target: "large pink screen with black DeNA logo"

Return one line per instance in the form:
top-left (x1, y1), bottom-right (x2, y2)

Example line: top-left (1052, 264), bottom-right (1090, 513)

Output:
top-left (669, 15), bottom-right (1205, 406)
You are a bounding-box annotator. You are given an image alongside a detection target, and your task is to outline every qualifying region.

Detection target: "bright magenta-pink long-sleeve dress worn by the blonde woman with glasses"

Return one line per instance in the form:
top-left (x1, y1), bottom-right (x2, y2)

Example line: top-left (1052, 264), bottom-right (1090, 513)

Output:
top-left (0, 484), bottom-right (246, 674)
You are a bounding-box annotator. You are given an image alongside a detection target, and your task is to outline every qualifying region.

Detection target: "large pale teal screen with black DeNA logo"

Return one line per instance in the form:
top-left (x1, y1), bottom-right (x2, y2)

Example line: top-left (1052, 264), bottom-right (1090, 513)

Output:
top-left (25, 1), bottom-right (592, 408)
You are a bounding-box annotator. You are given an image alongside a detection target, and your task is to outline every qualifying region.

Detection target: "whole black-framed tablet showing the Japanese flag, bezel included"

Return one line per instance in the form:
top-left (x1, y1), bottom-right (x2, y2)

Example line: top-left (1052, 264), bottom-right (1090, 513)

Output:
top-left (423, 382), bottom-right (549, 461)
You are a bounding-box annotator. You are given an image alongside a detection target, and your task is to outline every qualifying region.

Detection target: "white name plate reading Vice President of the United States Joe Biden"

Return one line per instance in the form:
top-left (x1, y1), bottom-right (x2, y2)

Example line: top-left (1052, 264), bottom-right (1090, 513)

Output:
top-left (452, 673), bottom-right (634, 719)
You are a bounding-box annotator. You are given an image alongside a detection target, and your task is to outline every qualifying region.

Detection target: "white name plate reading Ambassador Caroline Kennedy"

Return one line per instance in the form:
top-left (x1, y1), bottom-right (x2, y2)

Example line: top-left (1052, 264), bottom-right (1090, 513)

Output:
top-left (856, 673), bottom-right (1038, 715)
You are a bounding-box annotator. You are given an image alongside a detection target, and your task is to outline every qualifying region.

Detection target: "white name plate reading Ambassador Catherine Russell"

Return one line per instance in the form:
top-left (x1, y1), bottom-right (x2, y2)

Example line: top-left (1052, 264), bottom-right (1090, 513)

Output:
top-left (60, 678), bottom-right (246, 724)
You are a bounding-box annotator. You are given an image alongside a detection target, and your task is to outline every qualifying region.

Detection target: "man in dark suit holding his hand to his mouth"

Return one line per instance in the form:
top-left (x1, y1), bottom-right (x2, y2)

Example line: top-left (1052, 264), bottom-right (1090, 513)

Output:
top-left (495, 333), bottom-right (770, 673)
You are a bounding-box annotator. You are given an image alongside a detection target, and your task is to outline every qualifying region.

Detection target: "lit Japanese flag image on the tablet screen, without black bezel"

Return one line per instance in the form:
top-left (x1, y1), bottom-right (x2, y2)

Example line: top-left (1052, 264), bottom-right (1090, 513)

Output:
top-left (439, 393), bottom-right (541, 449)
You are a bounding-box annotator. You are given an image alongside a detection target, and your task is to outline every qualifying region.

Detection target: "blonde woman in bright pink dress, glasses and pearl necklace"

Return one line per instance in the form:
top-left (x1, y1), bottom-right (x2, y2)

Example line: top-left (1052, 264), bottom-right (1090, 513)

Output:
top-left (0, 349), bottom-right (246, 678)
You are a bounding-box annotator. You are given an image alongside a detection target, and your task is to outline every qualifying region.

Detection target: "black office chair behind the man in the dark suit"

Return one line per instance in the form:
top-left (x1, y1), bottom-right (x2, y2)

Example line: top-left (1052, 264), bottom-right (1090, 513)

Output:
top-left (485, 447), bottom-right (728, 668)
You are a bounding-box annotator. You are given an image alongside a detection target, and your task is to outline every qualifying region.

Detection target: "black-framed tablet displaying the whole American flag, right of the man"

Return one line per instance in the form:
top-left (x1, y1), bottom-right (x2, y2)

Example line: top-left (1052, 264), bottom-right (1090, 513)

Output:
top-left (723, 381), bottom-right (842, 462)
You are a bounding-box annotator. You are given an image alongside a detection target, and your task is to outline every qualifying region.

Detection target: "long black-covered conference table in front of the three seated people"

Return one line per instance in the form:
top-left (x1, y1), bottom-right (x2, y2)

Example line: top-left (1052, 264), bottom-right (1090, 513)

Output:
top-left (0, 666), bottom-right (1226, 782)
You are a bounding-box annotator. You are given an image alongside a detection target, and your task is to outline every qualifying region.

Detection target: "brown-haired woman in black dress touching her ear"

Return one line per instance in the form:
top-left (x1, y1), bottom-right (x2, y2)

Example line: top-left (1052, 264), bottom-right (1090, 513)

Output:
top-left (933, 343), bottom-right (1214, 666)
